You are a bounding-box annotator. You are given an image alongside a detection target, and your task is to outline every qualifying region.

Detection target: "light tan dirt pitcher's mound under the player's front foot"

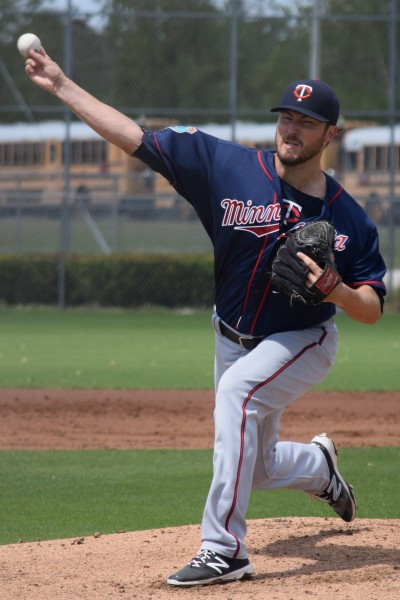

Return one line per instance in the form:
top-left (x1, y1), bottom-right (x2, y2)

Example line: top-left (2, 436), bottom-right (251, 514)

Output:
top-left (0, 518), bottom-right (400, 600)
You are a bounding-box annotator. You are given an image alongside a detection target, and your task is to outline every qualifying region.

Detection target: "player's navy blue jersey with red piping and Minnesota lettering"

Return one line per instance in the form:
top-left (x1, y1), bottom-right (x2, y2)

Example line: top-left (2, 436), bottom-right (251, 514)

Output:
top-left (135, 127), bottom-right (386, 336)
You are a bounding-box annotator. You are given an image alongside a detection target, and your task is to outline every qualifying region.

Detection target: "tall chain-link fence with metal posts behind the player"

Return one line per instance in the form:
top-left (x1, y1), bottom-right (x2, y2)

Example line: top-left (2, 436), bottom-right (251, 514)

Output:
top-left (0, 0), bottom-right (400, 306)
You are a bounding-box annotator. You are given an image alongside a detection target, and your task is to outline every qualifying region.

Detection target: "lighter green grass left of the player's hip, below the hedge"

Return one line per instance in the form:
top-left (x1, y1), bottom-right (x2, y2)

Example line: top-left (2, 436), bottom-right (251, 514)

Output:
top-left (0, 309), bottom-right (214, 389)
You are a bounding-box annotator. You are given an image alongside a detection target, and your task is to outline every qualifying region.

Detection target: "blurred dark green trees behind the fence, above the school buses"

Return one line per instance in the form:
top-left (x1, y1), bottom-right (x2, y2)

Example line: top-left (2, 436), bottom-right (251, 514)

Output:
top-left (0, 0), bottom-right (398, 122)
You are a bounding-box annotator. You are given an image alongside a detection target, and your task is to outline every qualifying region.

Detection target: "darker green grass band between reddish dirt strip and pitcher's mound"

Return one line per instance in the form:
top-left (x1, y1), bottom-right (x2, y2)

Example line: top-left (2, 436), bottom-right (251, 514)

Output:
top-left (0, 448), bottom-right (400, 544)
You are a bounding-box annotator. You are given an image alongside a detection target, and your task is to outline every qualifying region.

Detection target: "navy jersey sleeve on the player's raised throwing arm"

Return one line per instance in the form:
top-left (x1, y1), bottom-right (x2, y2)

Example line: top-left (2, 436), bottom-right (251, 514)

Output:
top-left (134, 127), bottom-right (218, 208)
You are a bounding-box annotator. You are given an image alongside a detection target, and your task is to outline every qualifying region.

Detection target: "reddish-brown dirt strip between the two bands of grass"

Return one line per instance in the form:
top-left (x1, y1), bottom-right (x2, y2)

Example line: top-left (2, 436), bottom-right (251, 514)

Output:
top-left (0, 389), bottom-right (400, 450)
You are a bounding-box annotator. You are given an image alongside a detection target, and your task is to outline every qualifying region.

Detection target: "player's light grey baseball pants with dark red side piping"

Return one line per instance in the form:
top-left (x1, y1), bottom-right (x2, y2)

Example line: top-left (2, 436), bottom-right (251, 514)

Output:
top-left (202, 328), bottom-right (336, 558)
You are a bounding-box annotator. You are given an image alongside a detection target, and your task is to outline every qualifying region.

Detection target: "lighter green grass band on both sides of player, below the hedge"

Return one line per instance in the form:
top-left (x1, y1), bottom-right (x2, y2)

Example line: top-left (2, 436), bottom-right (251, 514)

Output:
top-left (0, 308), bottom-right (400, 390)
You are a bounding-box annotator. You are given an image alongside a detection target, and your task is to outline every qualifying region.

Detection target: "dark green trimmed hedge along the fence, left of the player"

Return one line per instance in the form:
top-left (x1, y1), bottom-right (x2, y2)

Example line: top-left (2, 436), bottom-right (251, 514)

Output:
top-left (0, 254), bottom-right (214, 308)
